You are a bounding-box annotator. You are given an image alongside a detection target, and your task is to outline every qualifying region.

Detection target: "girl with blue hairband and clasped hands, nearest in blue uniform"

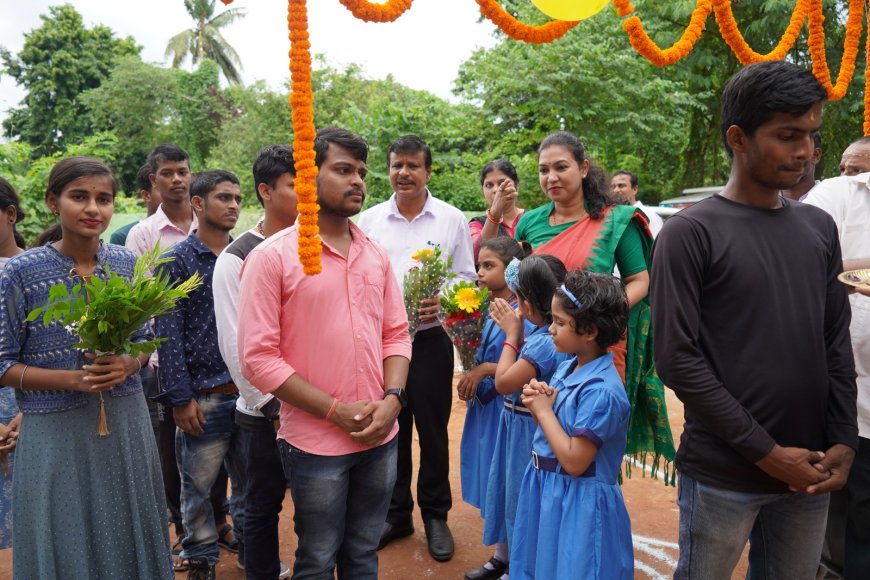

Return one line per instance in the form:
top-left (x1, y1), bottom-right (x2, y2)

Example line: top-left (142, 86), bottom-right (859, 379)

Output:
top-left (510, 271), bottom-right (634, 580)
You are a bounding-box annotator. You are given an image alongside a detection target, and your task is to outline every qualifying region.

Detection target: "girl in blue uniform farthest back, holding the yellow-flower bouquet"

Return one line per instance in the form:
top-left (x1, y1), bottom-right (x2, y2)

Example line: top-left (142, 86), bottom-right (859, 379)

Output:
top-left (456, 236), bottom-right (526, 578)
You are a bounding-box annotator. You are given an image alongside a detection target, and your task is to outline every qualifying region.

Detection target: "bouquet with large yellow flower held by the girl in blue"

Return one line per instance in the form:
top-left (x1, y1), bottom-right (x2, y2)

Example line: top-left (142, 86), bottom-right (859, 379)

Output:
top-left (439, 282), bottom-right (489, 372)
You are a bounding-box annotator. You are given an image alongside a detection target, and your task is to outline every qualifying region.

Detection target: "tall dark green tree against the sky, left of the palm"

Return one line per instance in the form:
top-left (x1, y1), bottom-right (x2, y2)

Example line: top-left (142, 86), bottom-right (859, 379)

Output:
top-left (0, 4), bottom-right (140, 156)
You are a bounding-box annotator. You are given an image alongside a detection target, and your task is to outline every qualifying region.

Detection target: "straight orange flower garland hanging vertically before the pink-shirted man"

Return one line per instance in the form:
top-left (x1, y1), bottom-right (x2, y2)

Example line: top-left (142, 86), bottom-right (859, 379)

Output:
top-left (287, 0), bottom-right (322, 276)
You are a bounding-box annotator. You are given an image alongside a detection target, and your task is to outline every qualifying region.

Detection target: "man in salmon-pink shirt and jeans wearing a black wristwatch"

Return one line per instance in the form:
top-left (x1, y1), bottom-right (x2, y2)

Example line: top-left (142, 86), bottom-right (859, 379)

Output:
top-left (238, 127), bottom-right (411, 578)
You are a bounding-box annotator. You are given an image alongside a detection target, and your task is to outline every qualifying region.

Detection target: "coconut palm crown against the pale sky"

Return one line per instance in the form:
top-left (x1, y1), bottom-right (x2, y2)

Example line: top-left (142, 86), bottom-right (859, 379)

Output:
top-left (165, 0), bottom-right (247, 84)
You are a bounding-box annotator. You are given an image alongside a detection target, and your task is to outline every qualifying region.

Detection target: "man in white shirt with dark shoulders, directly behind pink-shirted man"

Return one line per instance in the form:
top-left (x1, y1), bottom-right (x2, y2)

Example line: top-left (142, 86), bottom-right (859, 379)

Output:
top-left (212, 145), bottom-right (297, 578)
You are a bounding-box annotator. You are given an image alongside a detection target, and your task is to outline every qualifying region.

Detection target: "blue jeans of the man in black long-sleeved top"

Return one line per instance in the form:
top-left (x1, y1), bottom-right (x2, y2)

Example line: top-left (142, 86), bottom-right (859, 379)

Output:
top-left (674, 473), bottom-right (829, 580)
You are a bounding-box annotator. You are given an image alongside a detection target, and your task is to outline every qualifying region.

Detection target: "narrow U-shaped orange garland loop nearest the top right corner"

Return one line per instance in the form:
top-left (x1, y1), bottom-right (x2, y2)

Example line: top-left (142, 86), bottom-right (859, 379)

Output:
top-left (808, 0), bottom-right (867, 99)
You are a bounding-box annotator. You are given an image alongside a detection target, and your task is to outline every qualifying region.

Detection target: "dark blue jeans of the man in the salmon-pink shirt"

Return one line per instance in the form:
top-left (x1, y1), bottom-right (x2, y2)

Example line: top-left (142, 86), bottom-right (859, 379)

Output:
top-left (278, 438), bottom-right (396, 580)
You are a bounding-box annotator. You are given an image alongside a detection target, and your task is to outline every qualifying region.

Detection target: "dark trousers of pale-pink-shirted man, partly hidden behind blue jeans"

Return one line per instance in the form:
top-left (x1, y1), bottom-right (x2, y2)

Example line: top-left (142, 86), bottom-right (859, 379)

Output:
top-left (157, 404), bottom-right (230, 538)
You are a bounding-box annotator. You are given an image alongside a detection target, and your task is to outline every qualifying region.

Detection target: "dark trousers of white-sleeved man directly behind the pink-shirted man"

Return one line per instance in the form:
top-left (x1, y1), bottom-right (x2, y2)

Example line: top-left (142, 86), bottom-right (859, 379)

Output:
top-left (236, 412), bottom-right (287, 580)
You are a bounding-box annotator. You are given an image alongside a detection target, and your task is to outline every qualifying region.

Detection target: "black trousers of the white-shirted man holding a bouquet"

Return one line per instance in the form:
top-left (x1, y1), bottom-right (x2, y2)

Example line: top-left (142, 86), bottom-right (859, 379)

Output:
top-left (387, 326), bottom-right (453, 525)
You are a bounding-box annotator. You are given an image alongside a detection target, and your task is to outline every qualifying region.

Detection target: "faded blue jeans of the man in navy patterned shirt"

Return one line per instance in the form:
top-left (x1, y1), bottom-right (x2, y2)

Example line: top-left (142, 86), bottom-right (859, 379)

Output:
top-left (175, 394), bottom-right (245, 563)
